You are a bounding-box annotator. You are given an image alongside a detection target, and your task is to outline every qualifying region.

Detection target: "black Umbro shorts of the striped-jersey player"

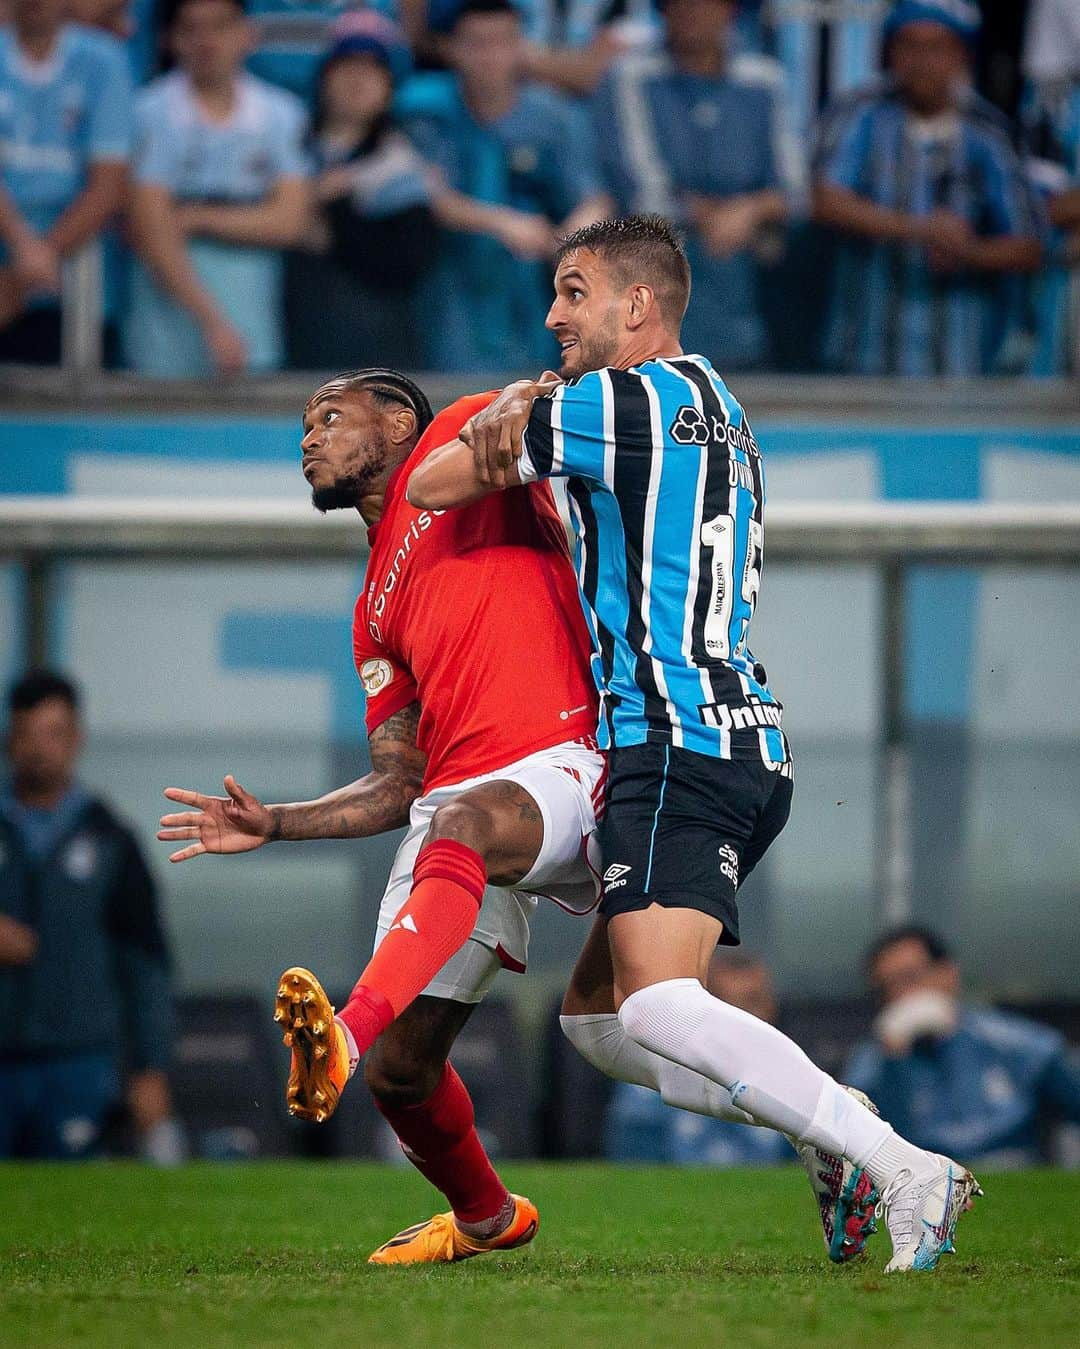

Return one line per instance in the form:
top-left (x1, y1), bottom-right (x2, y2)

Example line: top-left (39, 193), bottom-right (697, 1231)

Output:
top-left (599, 745), bottom-right (791, 946)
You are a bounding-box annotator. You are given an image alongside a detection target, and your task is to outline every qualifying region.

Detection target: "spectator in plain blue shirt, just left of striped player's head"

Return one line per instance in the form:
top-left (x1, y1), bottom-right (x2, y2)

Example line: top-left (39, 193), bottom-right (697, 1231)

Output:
top-left (407, 0), bottom-right (608, 371)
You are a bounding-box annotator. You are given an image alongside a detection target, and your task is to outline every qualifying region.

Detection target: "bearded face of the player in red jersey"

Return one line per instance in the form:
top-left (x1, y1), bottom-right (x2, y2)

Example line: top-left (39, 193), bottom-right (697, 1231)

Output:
top-left (301, 383), bottom-right (391, 511)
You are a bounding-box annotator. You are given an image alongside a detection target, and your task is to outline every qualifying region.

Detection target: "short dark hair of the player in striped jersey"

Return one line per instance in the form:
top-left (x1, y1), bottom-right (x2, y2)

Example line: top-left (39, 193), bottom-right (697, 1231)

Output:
top-left (556, 216), bottom-right (690, 332)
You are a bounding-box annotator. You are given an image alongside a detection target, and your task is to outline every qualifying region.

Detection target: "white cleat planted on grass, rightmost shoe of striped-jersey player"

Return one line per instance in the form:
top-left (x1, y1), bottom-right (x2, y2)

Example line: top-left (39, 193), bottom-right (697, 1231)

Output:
top-left (878, 1156), bottom-right (983, 1273)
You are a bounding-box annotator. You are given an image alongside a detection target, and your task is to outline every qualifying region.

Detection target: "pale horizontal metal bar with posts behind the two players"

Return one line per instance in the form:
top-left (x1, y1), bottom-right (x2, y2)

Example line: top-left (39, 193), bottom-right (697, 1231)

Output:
top-left (0, 496), bottom-right (1080, 923)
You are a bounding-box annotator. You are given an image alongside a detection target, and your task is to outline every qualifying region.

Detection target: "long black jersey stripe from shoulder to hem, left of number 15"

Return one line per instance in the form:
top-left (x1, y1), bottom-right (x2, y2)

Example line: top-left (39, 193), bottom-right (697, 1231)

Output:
top-left (608, 370), bottom-right (671, 741)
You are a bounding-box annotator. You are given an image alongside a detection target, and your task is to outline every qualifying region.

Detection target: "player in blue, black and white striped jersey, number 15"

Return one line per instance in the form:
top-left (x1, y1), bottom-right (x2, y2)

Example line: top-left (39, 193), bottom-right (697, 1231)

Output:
top-left (407, 216), bottom-right (979, 1271)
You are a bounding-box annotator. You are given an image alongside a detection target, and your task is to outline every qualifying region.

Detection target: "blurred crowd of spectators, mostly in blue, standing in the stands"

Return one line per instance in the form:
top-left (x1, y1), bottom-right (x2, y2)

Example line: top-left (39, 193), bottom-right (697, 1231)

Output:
top-left (0, 0), bottom-right (1080, 378)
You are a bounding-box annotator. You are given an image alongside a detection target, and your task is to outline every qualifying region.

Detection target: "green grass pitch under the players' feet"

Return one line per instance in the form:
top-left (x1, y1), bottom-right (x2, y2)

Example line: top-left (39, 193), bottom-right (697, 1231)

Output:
top-left (0, 1163), bottom-right (1080, 1349)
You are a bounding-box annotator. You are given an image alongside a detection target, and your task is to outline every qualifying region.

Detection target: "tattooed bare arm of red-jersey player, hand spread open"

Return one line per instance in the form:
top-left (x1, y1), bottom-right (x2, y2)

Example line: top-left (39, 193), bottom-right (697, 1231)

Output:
top-left (158, 703), bottom-right (425, 862)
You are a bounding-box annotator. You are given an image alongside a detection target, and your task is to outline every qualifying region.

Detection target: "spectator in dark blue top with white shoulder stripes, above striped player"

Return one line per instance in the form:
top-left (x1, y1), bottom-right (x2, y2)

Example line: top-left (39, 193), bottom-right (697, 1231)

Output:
top-left (595, 0), bottom-right (787, 370)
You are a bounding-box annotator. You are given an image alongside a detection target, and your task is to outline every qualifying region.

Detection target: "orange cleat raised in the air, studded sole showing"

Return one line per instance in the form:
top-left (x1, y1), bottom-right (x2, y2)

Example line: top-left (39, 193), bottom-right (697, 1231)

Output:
top-left (274, 966), bottom-right (349, 1124)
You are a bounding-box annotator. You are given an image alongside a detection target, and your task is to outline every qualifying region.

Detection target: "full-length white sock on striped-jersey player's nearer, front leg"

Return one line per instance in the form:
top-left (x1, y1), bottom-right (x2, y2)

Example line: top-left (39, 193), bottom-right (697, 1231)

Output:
top-left (612, 979), bottom-right (929, 1183)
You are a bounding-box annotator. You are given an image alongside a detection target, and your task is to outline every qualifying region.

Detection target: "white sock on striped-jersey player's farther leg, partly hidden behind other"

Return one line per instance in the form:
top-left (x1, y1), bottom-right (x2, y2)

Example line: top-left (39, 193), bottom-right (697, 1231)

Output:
top-left (558, 1012), bottom-right (758, 1125)
